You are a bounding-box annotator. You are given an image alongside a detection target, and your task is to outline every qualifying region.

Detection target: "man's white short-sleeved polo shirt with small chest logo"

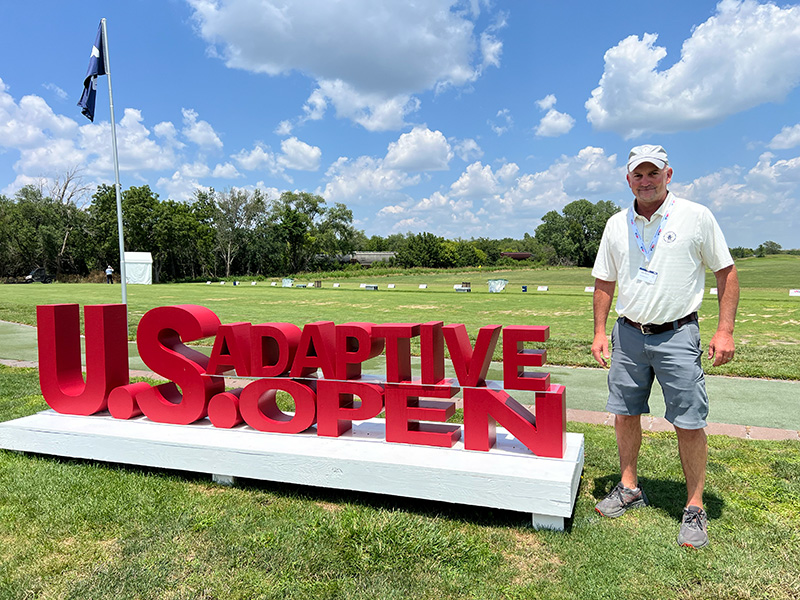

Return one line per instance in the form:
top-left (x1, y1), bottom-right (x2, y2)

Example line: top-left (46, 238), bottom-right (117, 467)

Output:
top-left (592, 192), bottom-right (733, 324)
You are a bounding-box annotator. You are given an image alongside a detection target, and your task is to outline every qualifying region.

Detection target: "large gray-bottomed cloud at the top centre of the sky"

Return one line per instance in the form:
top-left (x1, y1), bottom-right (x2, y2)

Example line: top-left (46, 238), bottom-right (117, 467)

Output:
top-left (189, 0), bottom-right (504, 131)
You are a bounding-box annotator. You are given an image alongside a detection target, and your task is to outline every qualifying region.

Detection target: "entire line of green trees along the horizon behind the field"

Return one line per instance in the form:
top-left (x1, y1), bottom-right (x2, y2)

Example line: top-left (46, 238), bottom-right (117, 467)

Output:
top-left (0, 180), bottom-right (781, 282)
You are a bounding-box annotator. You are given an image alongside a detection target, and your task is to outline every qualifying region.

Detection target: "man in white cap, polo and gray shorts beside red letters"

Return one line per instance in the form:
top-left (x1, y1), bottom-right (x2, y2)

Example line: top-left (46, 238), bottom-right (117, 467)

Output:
top-left (592, 145), bottom-right (739, 548)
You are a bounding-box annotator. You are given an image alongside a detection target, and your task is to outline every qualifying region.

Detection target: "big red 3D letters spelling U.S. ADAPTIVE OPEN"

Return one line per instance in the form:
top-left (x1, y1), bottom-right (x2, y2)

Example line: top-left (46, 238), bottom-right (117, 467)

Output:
top-left (36, 304), bottom-right (566, 458)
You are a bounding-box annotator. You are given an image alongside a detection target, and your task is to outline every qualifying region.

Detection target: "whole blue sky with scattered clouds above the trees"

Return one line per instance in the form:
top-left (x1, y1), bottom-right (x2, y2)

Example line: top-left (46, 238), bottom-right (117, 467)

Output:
top-left (0, 0), bottom-right (800, 250)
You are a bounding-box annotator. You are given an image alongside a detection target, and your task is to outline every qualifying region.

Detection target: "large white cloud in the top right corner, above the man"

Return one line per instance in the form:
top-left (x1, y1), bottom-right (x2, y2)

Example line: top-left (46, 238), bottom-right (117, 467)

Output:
top-left (586, 0), bottom-right (800, 138)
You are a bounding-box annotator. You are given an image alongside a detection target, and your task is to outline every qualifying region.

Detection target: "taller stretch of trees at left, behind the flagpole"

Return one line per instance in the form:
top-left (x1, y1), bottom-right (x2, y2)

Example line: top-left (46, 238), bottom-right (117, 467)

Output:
top-left (0, 185), bottom-right (364, 281)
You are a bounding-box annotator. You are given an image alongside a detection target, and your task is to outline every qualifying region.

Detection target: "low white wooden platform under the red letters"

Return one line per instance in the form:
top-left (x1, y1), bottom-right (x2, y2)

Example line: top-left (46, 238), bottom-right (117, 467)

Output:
top-left (0, 410), bottom-right (583, 530)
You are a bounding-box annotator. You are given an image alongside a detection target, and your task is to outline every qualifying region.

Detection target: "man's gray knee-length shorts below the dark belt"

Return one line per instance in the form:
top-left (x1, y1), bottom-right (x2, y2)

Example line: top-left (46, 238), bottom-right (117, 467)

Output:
top-left (606, 318), bottom-right (708, 429)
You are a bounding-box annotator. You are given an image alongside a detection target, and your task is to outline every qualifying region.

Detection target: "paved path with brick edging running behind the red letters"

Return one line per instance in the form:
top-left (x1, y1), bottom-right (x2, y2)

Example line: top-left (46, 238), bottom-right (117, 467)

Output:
top-left (0, 321), bottom-right (800, 440)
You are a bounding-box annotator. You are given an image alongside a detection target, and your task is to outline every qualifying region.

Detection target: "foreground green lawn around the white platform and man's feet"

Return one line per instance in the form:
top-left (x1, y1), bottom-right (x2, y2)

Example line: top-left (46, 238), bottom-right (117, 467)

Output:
top-left (0, 366), bottom-right (800, 600)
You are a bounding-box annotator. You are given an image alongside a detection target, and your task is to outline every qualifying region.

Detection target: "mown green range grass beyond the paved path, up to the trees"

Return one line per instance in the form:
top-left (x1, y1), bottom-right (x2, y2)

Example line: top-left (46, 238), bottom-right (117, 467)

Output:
top-left (0, 255), bottom-right (800, 380)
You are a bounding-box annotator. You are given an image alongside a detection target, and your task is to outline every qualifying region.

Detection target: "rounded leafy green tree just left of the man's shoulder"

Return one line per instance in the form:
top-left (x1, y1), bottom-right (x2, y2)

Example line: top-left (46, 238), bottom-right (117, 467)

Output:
top-left (536, 200), bottom-right (619, 267)
